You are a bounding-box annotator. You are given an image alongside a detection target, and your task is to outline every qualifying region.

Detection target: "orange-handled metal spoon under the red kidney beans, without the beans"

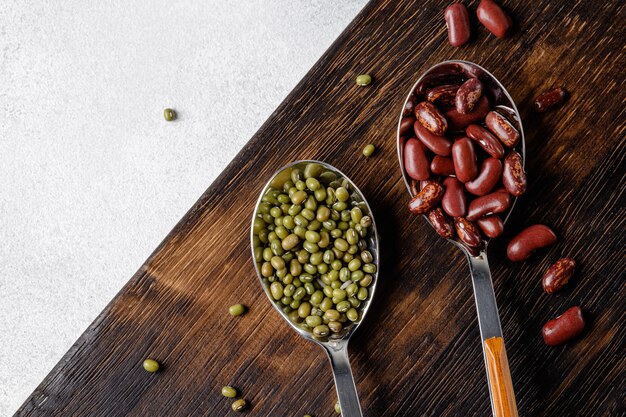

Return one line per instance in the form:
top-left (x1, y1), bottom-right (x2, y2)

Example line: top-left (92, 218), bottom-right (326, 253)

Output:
top-left (397, 61), bottom-right (525, 417)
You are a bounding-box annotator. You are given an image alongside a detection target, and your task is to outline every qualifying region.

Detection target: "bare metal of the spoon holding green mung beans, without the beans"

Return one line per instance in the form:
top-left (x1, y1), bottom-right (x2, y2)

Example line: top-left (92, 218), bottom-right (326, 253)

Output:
top-left (250, 160), bottom-right (379, 417)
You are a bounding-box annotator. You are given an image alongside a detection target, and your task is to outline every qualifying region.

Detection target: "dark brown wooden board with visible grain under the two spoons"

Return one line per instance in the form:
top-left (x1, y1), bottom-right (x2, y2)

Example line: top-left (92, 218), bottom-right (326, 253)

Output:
top-left (17, 0), bottom-right (626, 417)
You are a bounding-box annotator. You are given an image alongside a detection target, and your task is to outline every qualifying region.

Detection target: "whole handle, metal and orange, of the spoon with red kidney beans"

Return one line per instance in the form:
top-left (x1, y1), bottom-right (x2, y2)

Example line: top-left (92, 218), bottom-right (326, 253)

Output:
top-left (468, 252), bottom-right (518, 417)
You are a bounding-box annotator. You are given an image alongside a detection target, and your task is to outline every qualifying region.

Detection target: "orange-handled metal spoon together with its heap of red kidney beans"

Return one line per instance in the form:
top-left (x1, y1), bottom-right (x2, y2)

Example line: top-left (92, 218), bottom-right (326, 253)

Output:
top-left (397, 61), bottom-right (526, 417)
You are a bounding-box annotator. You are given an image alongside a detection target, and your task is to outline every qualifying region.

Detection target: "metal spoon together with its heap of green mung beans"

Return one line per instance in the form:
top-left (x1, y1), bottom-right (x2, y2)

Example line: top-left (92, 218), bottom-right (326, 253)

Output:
top-left (250, 161), bottom-right (379, 417)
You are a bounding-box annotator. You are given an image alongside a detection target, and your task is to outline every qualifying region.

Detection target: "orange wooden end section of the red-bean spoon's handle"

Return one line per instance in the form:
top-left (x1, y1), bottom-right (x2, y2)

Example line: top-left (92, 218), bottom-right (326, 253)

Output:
top-left (485, 337), bottom-right (518, 417)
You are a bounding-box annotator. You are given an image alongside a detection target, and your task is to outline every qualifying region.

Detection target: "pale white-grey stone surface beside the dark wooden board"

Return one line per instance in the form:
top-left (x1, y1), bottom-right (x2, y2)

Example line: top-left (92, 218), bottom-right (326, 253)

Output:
top-left (0, 0), bottom-right (366, 416)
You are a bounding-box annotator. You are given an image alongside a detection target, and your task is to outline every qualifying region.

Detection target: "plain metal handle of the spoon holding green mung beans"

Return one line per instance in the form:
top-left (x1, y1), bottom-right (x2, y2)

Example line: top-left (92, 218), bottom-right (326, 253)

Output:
top-left (324, 341), bottom-right (363, 417)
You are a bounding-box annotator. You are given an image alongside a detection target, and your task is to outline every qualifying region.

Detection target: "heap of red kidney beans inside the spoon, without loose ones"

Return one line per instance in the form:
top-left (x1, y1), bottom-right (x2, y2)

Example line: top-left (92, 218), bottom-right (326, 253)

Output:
top-left (400, 78), bottom-right (528, 253)
